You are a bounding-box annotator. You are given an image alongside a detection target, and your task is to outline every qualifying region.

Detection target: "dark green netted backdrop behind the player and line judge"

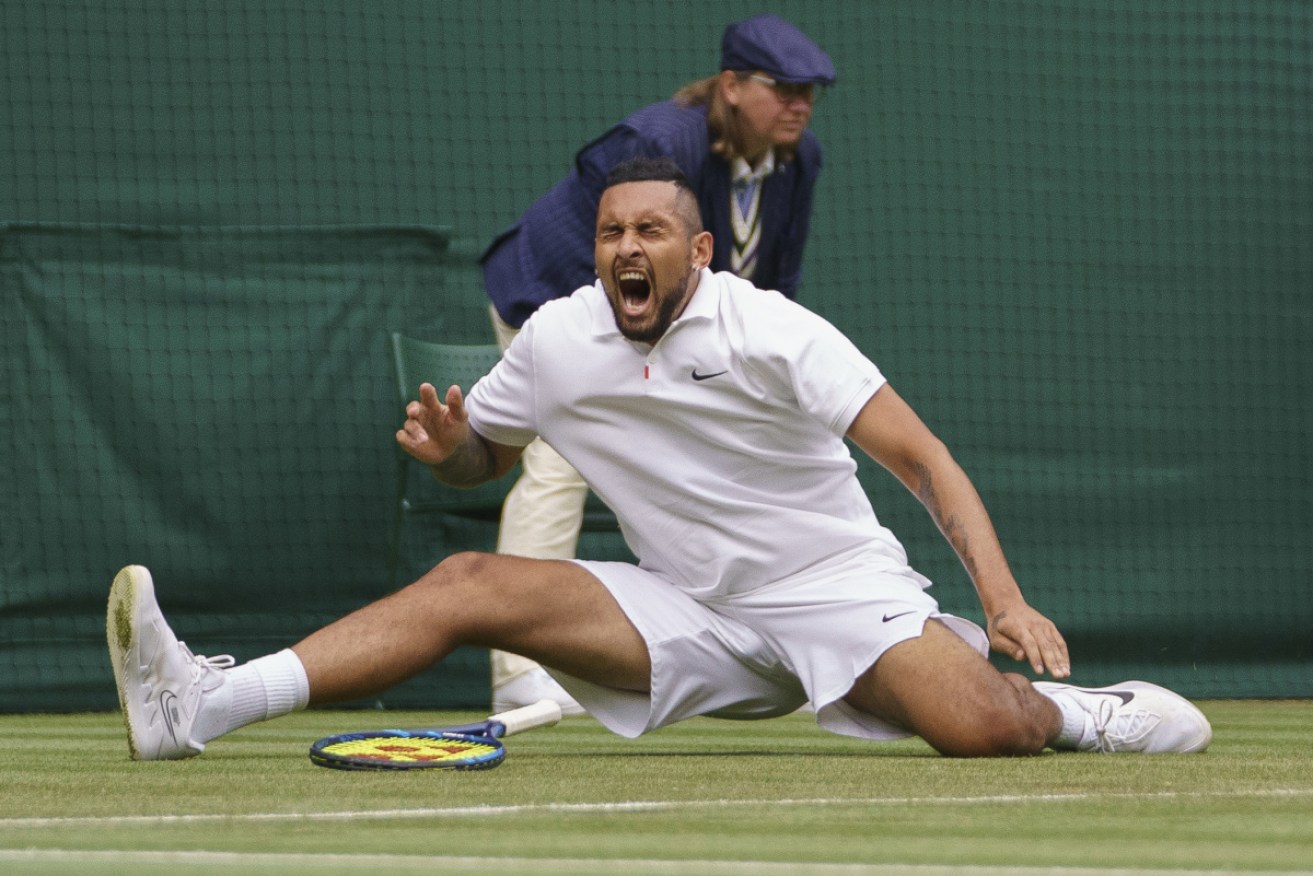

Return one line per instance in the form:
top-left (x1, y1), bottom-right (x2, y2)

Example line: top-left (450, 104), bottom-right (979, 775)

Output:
top-left (0, 0), bottom-right (1313, 711)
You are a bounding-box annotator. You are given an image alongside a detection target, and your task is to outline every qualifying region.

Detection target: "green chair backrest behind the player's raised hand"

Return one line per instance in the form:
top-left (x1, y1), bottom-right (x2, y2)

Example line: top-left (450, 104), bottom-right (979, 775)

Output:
top-left (390, 332), bottom-right (515, 520)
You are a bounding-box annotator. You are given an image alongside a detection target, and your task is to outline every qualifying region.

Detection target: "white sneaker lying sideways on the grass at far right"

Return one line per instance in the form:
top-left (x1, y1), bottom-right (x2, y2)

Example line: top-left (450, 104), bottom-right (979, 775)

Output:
top-left (1035, 682), bottom-right (1213, 754)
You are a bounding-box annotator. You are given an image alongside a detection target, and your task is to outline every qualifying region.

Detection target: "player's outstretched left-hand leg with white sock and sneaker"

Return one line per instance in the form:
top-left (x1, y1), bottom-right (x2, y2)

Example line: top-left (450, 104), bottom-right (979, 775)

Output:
top-left (106, 553), bottom-right (651, 760)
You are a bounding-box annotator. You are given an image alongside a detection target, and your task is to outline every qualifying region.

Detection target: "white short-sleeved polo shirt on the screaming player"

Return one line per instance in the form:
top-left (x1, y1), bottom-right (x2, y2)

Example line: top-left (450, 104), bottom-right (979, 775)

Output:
top-left (467, 269), bottom-right (906, 600)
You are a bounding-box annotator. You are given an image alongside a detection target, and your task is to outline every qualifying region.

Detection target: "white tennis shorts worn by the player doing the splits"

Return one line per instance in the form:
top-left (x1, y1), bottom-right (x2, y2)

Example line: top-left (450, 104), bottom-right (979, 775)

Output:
top-left (549, 554), bottom-right (989, 739)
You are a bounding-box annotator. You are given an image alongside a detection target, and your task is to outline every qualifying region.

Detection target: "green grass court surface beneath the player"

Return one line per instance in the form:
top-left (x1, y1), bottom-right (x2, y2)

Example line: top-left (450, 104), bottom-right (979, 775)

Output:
top-left (0, 700), bottom-right (1313, 876)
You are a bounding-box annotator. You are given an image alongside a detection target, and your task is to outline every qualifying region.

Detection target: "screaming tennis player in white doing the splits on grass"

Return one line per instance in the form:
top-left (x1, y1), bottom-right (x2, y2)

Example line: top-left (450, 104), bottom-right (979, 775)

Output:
top-left (108, 159), bottom-right (1212, 759)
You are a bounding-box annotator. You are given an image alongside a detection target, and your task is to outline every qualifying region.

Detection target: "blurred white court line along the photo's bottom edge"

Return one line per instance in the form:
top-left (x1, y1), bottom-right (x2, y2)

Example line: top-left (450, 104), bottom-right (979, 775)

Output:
top-left (0, 850), bottom-right (1313, 876)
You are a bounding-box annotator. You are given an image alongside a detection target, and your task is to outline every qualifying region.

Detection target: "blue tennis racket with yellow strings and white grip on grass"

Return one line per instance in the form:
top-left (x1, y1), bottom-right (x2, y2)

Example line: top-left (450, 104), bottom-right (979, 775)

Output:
top-left (310, 700), bottom-right (561, 770)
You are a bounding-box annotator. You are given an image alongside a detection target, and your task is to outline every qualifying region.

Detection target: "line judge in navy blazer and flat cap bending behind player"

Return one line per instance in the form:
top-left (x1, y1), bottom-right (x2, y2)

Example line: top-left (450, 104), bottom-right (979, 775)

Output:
top-left (482, 14), bottom-right (835, 713)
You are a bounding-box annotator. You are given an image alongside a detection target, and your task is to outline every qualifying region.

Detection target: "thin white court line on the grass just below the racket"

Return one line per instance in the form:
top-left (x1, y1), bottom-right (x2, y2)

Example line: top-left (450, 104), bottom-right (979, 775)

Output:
top-left (0, 788), bottom-right (1313, 829)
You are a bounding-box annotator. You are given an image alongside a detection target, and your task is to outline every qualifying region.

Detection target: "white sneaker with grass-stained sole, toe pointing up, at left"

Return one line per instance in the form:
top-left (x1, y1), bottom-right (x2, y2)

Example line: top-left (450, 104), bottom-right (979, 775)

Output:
top-left (105, 566), bottom-right (235, 760)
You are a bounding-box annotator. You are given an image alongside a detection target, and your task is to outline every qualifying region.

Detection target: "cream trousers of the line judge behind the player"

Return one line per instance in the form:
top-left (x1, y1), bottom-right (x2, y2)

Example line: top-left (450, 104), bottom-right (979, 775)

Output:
top-left (488, 307), bottom-right (588, 687)
